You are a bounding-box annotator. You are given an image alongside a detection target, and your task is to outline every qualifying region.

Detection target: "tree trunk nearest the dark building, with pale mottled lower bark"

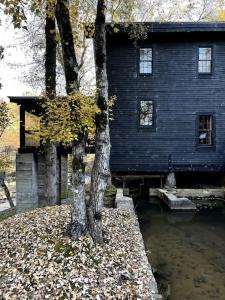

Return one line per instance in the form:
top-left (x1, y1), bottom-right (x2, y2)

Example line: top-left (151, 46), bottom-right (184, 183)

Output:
top-left (88, 0), bottom-right (110, 242)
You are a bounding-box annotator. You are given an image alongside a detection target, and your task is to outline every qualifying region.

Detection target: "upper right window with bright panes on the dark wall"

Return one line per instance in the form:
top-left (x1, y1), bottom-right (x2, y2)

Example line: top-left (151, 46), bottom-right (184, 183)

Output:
top-left (198, 47), bottom-right (212, 74)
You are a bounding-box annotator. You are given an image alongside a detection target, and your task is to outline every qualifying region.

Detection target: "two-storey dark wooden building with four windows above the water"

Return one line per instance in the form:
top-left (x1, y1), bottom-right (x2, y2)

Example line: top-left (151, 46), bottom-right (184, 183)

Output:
top-left (107, 22), bottom-right (225, 178)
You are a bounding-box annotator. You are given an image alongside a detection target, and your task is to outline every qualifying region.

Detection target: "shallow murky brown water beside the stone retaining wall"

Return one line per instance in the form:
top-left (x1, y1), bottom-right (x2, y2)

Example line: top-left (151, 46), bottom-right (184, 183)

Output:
top-left (136, 198), bottom-right (225, 300)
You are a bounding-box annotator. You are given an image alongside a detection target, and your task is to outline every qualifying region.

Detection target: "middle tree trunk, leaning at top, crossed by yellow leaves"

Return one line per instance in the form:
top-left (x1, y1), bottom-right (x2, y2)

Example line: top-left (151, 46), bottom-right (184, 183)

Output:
top-left (56, 0), bottom-right (87, 239)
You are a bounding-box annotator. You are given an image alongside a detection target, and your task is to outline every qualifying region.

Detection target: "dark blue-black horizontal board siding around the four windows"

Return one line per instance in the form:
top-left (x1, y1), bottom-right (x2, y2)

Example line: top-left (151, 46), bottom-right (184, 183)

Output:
top-left (107, 37), bottom-right (225, 172)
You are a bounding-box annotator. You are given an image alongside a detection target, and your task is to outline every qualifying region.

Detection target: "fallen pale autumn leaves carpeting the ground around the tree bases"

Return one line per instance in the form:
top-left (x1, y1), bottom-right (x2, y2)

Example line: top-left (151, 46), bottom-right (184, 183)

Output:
top-left (0, 205), bottom-right (155, 300)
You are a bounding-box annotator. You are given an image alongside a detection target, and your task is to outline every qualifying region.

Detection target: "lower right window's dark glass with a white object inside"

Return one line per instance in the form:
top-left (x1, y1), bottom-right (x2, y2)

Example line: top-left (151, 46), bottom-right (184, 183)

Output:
top-left (199, 115), bottom-right (212, 145)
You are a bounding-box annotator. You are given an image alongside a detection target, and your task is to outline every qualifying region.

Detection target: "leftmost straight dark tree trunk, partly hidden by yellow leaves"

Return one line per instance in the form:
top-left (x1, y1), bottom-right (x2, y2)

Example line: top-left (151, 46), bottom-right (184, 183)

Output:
top-left (44, 7), bottom-right (57, 205)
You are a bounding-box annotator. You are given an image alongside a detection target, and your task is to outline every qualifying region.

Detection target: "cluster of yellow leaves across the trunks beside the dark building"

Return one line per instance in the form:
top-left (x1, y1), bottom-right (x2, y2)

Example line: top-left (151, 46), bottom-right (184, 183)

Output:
top-left (40, 92), bottom-right (99, 145)
